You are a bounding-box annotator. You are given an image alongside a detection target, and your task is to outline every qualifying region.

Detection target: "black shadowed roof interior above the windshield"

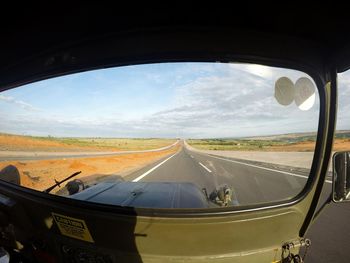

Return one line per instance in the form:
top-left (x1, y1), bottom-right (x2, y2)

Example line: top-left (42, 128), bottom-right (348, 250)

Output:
top-left (0, 2), bottom-right (350, 90)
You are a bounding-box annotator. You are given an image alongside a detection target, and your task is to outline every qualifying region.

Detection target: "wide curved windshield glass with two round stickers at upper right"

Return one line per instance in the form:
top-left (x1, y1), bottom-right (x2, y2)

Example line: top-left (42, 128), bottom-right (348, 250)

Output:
top-left (0, 63), bottom-right (319, 208)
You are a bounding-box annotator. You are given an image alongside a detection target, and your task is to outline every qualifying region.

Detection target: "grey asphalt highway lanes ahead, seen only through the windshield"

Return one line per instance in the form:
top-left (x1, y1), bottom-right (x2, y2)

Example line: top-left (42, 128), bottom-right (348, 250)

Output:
top-left (126, 142), bottom-right (306, 205)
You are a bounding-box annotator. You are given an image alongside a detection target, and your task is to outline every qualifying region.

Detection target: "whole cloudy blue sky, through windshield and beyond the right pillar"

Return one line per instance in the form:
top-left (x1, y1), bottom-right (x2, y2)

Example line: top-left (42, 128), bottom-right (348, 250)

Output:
top-left (0, 63), bottom-right (344, 138)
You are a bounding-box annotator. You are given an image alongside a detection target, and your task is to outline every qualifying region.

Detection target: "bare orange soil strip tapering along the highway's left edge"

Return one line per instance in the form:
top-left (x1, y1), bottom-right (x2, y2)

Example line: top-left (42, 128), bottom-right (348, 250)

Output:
top-left (0, 145), bottom-right (181, 191)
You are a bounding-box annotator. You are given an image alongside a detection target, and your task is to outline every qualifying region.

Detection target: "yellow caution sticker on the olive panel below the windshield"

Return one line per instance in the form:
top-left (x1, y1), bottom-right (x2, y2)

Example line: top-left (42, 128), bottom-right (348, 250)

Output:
top-left (51, 213), bottom-right (94, 243)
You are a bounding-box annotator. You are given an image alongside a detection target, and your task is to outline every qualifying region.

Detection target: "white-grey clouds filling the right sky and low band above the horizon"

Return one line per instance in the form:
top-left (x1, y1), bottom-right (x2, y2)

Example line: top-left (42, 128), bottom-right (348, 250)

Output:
top-left (0, 64), bottom-right (318, 138)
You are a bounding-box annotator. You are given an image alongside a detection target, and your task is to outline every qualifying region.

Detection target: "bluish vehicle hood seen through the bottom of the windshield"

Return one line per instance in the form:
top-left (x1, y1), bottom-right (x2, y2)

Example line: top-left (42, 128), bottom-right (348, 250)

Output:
top-left (70, 181), bottom-right (214, 208)
